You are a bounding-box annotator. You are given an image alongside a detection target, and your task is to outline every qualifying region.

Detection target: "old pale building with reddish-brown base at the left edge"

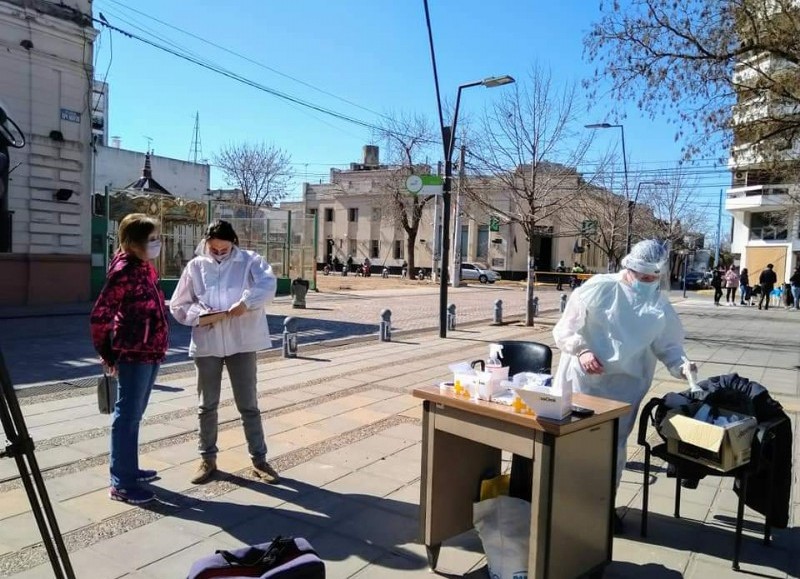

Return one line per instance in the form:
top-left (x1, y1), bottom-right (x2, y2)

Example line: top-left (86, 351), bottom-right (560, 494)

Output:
top-left (0, 0), bottom-right (96, 305)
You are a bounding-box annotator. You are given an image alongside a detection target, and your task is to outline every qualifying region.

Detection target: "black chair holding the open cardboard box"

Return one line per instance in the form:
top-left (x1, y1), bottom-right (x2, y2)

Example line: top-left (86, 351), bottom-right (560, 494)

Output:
top-left (638, 398), bottom-right (785, 571)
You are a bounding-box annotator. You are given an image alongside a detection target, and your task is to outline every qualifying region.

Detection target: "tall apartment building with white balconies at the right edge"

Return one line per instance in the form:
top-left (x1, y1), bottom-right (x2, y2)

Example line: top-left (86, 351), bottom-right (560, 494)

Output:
top-left (725, 3), bottom-right (800, 282)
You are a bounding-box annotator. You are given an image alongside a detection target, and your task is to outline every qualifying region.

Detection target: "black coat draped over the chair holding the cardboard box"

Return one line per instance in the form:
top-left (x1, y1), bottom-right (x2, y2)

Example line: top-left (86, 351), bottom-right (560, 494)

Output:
top-left (656, 373), bottom-right (792, 529)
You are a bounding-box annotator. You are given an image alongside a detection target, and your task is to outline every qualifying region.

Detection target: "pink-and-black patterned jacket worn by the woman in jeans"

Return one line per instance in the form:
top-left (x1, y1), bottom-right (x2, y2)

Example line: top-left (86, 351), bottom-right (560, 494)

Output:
top-left (90, 252), bottom-right (169, 366)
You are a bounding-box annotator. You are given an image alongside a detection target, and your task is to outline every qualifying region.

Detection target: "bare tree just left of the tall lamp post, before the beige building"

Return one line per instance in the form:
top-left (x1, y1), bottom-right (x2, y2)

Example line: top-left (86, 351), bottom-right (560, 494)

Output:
top-left (378, 114), bottom-right (436, 274)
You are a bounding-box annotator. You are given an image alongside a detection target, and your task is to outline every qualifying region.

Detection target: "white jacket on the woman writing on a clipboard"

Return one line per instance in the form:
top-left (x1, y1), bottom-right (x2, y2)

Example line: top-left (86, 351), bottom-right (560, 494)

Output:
top-left (169, 244), bottom-right (277, 358)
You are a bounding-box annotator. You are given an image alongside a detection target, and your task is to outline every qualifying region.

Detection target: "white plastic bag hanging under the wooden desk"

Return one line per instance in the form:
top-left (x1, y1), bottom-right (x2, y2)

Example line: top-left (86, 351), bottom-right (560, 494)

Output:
top-left (472, 496), bottom-right (531, 579)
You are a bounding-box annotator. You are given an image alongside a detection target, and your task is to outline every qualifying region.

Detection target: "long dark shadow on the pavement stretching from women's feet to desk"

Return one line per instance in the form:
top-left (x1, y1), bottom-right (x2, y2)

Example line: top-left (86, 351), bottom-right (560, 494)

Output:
top-left (143, 473), bottom-right (480, 577)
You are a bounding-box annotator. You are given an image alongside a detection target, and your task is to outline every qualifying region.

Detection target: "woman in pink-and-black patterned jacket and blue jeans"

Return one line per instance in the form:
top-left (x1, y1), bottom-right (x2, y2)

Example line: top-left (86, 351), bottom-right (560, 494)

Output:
top-left (90, 213), bottom-right (169, 505)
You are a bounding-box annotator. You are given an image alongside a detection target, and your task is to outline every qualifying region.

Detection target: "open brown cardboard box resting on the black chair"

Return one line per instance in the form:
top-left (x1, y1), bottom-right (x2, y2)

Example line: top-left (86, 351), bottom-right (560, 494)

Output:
top-left (661, 410), bottom-right (758, 472)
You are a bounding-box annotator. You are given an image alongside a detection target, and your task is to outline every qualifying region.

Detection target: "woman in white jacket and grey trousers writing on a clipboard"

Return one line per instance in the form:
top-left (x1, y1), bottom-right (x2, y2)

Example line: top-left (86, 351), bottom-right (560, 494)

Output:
top-left (170, 220), bottom-right (279, 484)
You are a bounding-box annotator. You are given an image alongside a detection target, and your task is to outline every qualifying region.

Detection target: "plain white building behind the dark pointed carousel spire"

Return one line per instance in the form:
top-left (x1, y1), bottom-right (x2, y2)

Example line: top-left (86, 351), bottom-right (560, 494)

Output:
top-left (94, 144), bottom-right (211, 201)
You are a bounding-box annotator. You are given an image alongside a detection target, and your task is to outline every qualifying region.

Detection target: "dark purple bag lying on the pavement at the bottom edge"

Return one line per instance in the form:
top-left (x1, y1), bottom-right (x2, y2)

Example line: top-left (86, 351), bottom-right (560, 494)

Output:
top-left (188, 537), bottom-right (325, 579)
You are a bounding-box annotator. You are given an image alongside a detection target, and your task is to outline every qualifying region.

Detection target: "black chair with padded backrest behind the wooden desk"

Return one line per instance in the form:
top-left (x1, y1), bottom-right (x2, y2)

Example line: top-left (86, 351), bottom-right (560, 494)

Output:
top-left (494, 340), bottom-right (553, 502)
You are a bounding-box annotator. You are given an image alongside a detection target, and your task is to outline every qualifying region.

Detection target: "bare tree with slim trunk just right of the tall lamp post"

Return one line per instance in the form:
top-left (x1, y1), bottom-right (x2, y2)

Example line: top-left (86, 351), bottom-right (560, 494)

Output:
top-left (465, 66), bottom-right (592, 326)
